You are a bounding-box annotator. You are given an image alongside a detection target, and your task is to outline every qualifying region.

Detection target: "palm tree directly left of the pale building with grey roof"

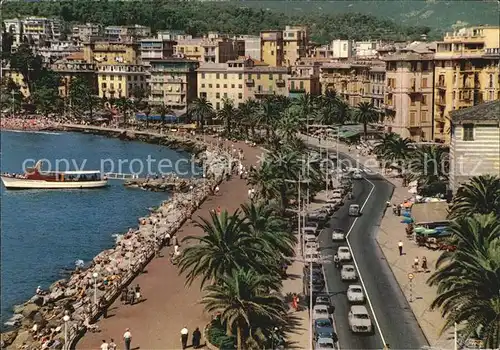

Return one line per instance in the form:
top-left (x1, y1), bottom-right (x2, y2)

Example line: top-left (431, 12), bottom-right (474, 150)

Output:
top-left (407, 145), bottom-right (448, 195)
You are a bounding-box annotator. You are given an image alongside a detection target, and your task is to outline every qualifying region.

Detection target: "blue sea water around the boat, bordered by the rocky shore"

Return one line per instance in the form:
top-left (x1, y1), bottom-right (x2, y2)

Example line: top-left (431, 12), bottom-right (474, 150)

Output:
top-left (0, 131), bottom-right (200, 329)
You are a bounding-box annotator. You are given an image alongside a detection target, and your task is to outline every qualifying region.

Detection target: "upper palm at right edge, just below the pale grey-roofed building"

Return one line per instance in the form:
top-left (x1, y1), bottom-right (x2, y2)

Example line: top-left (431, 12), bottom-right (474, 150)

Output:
top-left (450, 175), bottom-right (500, 219)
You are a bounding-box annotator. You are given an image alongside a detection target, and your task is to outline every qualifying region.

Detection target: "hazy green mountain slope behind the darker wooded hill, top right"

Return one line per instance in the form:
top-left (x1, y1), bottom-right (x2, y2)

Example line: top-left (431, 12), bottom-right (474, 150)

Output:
top-left (235, 0), bottom-right (500, 31)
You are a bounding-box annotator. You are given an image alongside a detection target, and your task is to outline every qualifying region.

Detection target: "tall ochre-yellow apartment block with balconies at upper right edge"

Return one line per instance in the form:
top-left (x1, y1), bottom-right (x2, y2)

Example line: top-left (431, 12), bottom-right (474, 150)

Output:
top-left (434, 27), bottom-right (500, 143)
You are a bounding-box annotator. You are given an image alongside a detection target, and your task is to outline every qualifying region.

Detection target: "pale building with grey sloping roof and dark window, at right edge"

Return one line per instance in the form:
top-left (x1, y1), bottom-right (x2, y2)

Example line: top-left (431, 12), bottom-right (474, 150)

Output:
top-left (450, 100), bottom-right (500, 192)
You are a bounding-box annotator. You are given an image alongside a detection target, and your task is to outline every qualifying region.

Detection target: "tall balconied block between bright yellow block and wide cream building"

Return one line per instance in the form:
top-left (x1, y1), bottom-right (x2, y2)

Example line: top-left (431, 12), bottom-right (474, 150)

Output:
top-left (147, 57), bottom-right (200, 112)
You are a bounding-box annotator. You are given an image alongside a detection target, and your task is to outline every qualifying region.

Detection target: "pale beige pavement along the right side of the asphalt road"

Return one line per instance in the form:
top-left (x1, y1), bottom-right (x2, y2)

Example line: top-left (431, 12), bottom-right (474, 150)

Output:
top-left (309, 137), bottom-right (453, 349)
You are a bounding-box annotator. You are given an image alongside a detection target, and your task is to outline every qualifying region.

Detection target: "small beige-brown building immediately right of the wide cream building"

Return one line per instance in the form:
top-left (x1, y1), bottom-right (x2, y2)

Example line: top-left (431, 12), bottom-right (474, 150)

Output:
top-left (288, 58), bottom-right (321, 98)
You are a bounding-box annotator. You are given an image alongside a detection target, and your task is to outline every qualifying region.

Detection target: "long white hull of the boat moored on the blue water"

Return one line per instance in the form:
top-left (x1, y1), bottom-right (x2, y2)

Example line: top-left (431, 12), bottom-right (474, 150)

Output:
top-left (2, 176), bottom-right (108, 190)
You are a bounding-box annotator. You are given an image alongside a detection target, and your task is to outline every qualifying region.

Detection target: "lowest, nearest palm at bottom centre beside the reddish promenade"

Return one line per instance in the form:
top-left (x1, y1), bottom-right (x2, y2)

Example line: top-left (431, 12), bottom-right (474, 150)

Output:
top-left (202, 270), bottom-right (286, 350)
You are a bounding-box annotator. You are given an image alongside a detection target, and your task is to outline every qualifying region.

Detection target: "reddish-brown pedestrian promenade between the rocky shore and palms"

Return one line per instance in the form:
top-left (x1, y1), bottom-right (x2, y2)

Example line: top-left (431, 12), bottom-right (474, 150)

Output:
top-left (77, 137), bottom-right (262, 349)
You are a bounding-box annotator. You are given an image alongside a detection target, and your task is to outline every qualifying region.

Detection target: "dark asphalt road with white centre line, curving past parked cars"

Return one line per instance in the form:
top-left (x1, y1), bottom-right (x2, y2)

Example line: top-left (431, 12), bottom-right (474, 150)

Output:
top-left (319, 154), bottom-right (428, 349)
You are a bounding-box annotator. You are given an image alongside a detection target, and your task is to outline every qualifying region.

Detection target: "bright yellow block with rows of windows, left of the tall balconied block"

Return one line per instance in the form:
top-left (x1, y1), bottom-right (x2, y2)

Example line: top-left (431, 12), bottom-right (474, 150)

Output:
top-left (96, 62), bottom-right (147, 99)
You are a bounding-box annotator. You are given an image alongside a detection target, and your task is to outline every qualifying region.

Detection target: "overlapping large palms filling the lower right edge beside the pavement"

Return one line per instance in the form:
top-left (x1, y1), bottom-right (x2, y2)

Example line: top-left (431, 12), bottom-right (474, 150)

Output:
top-left (428, 175), bottom-right (500, 349)
